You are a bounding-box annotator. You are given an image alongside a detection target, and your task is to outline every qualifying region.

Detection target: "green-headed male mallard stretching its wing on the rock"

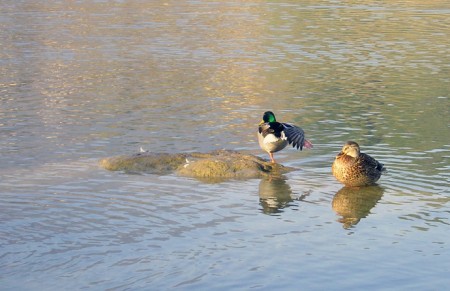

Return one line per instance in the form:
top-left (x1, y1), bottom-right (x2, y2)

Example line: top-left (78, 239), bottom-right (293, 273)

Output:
top-left (258, 111), bottom-right (313, 163)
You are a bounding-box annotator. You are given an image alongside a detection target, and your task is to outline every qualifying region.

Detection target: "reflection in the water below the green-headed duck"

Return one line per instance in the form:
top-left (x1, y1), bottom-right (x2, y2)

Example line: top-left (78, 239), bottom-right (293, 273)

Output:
top-left (259, 176), bottom-right (294, 214)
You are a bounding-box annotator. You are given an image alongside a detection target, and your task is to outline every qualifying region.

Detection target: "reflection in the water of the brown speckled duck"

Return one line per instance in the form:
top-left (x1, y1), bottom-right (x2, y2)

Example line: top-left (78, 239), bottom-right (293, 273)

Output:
top-left (332, 185), bottom-right (384, 229)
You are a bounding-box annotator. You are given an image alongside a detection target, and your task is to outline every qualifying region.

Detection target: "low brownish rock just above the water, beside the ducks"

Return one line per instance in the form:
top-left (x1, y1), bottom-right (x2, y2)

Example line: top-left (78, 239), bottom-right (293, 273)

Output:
top-left (100, 150), bottom-right (292, 180)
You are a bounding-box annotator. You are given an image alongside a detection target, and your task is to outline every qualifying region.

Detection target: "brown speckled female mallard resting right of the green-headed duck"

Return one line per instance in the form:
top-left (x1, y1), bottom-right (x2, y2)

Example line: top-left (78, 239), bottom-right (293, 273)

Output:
top-left (331, 141), bottom-right (386, 187)
